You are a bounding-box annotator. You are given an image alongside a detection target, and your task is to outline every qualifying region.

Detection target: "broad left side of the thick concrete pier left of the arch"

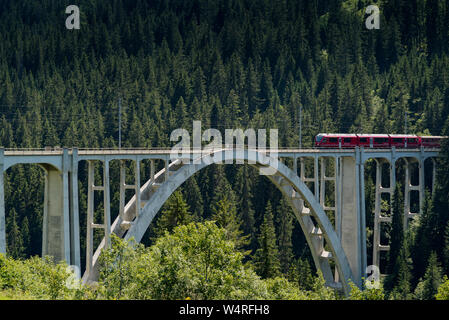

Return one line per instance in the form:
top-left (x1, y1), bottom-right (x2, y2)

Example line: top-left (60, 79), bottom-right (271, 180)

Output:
top-left (42, 149), bottom-right (71, 264)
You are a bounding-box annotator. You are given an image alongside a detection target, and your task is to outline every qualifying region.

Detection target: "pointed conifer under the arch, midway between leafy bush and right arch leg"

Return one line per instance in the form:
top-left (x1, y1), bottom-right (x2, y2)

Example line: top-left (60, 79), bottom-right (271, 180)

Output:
top-left (254, 202), bottom-right (280, 278)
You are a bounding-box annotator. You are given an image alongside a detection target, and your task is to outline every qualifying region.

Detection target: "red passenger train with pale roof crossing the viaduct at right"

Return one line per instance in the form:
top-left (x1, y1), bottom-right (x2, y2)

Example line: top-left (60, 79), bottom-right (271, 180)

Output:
top-left (314, 133), bottom-right (447, 149)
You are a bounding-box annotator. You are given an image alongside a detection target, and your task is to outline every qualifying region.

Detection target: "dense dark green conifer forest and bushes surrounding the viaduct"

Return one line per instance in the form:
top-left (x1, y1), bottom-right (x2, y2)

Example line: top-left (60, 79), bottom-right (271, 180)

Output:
top-left (0, 0), bottom-right (449, 300)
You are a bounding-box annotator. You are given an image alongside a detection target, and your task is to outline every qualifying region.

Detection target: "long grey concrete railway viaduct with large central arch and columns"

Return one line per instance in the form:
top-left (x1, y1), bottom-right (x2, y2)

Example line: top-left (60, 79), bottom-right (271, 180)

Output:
top-left (0, 147), bottom-right (439, 293)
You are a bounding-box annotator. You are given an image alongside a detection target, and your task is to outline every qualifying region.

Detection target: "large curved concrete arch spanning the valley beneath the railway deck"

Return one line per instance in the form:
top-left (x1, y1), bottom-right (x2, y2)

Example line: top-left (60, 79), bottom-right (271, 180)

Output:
top-left (83, 150), bottom-right (353, 294)
